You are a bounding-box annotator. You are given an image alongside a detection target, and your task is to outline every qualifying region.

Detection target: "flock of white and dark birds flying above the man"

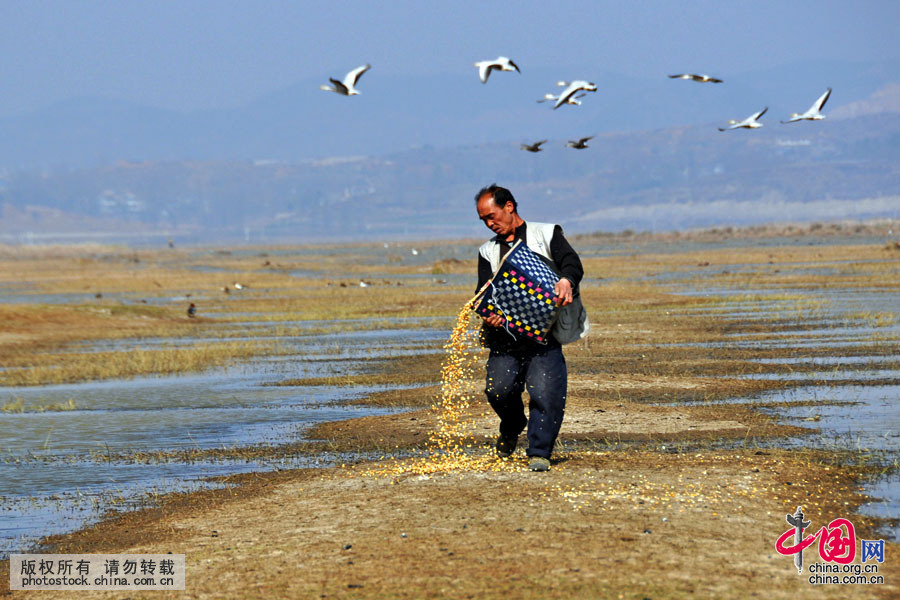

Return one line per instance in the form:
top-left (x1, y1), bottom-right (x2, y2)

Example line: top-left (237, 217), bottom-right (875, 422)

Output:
top-left (320, 56), bottom-right (831, 152)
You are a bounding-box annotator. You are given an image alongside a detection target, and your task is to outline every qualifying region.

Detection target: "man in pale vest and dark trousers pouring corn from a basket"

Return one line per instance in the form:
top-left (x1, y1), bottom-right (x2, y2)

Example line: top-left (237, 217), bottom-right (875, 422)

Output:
top-left (475, 184), bottom-right (586, 471)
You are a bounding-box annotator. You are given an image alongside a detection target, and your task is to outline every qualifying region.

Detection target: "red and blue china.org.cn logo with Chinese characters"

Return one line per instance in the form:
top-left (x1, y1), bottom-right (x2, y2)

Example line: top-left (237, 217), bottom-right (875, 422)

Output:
top-left (775, 506), bottom-right (884, 584)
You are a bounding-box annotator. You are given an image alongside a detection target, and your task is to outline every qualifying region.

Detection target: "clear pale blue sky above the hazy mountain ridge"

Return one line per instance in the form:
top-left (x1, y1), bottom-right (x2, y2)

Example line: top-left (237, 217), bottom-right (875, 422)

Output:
top-left (0, 0), bottom-right (900, 115)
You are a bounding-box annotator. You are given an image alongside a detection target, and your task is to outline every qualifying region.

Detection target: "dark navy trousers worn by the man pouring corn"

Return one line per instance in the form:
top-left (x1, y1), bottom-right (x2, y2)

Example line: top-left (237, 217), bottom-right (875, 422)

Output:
top-left (484, 344), bottom-right (567, 458)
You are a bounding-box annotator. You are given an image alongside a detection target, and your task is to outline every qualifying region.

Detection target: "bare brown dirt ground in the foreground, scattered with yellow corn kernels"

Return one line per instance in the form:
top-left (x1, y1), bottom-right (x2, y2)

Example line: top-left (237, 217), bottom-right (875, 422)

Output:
top-left (5, 451), bottom-right (900, 600)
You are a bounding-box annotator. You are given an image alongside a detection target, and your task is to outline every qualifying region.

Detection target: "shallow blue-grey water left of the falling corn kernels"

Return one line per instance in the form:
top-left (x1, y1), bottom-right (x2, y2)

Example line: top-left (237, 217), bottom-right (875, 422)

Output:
top-left (0, 322), bottom-right (447, 556)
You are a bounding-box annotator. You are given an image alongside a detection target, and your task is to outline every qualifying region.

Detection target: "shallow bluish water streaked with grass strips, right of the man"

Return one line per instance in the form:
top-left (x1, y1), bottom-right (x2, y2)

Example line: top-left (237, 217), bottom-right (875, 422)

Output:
top-left (670, 267), bottom-right (900, 542)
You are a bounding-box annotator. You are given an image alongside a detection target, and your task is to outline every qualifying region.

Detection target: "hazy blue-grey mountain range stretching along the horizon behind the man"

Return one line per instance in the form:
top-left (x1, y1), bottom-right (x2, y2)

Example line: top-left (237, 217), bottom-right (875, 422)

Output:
top-left (0, 113), bottom-right (900, 241)
